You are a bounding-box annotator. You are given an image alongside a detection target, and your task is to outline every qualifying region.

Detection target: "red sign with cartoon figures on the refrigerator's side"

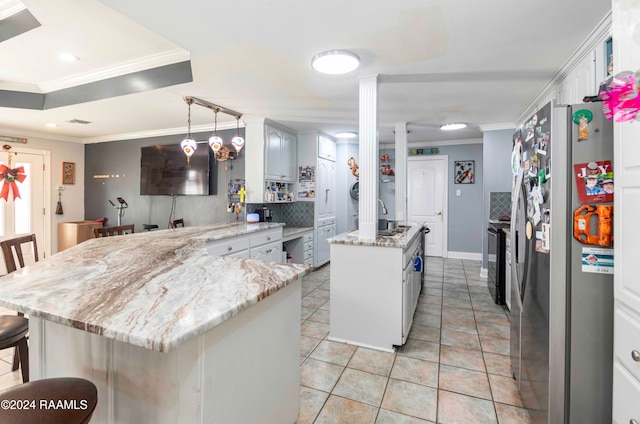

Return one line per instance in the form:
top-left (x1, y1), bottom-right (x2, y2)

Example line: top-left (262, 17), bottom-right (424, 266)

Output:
top-left (573, 160), bottom-right (613, 203)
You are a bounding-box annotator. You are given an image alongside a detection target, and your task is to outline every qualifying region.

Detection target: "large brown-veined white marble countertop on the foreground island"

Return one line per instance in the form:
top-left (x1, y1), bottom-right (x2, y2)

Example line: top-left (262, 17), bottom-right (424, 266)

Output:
top-left (0, 223), bottom-right (310, 352)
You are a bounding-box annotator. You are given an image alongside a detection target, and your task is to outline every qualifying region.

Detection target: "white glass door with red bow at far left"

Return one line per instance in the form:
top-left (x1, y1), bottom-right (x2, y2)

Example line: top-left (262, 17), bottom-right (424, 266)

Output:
top-left (0, 152), bottom-right (45, 274)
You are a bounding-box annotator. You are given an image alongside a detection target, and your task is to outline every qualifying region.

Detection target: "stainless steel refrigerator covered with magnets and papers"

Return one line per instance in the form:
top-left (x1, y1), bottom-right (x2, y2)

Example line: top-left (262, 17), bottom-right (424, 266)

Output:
top-left (510, 103), bottom-right (613, 424)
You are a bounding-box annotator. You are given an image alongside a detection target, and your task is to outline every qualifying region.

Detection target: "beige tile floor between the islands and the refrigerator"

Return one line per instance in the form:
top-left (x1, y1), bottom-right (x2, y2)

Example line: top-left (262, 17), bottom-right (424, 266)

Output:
top-left (297, 258), bottom-right (530, 424)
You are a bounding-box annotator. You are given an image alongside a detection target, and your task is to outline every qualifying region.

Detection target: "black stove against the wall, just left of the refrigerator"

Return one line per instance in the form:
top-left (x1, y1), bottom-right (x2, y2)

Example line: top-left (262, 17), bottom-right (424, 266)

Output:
top-left (487, 220), bottom-right (510, 305)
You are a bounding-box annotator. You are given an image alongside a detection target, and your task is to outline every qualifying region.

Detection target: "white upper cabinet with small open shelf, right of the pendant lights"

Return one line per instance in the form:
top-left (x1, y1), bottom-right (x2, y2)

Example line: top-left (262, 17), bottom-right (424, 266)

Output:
top-left (244, 118), bottom-right (298, 203)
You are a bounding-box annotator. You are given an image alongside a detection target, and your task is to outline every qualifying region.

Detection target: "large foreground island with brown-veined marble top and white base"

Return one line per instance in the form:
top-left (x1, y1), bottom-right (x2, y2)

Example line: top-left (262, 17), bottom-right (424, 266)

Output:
top-left (0, 224), bottom-right (309, 423)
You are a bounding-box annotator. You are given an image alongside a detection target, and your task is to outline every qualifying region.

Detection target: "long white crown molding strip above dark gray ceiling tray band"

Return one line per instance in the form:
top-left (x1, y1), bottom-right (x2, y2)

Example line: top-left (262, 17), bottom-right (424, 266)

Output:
top-left (38, 49), bottom-right (191, 93)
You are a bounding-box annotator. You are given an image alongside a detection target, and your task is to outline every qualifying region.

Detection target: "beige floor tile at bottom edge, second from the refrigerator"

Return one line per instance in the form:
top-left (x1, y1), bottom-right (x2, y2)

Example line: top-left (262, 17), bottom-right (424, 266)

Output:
top-left (438, 390), bottom-right (498, 424)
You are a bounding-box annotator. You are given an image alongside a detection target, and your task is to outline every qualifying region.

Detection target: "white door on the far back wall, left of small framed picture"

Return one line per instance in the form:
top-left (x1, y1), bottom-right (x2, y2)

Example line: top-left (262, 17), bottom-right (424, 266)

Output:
top-left (407, 156), bottom-right (448, 256)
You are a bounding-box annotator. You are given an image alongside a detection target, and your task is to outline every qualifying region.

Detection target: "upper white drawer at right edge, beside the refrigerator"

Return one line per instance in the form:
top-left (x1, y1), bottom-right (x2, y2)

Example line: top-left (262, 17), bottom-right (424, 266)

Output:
top-left (613, 309), bottom-right (640, 380)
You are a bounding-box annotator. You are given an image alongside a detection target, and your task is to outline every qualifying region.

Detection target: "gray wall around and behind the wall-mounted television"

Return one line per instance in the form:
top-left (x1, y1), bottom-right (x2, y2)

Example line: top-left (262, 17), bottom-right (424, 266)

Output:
top-left (84, 129), bottom-right (245, 231)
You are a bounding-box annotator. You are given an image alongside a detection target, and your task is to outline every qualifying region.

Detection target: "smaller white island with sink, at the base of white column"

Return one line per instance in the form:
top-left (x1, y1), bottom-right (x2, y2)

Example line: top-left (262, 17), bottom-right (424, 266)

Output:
top-left (328, 223), bottom-right (422, 352)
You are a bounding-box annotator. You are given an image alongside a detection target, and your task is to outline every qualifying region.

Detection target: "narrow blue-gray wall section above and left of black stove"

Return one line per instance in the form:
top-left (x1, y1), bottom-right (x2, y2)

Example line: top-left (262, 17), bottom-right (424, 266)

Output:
top-left (476, 128), bottom-right (515, 269)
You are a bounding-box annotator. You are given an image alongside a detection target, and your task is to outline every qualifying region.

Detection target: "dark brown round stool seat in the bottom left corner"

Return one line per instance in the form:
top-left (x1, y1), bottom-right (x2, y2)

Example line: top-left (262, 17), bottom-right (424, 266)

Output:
top-left (0, 378), bottom-right (98, 424)
